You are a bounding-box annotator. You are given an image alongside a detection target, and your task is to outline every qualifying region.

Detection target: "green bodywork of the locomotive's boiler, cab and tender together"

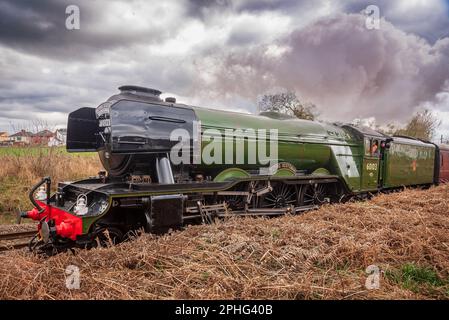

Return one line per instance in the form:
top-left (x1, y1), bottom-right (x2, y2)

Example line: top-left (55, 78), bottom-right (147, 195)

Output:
top-left (194, 108), bottom-right (435, 193)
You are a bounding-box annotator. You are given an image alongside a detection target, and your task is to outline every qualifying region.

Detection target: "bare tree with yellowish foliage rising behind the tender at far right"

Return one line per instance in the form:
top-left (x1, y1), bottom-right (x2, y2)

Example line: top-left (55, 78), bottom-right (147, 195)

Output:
top-left (392, 109), bottom-right (441, 140)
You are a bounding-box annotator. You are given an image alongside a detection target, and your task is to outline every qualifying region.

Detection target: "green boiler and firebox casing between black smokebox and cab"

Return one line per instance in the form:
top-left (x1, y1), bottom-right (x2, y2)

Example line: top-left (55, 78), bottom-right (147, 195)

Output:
top-left (194, 108), bottom-right (363, 192)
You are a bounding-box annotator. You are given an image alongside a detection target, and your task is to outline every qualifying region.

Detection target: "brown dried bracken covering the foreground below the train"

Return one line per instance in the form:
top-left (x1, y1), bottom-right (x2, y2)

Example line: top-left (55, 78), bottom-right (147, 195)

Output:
top-left (0, 186), bottom-right (449, 299)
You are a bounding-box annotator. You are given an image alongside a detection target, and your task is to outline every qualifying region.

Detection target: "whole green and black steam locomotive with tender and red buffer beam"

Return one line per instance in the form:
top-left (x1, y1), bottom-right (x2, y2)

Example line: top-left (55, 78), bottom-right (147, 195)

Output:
top-left (22, 86), bottom-right (449, 252)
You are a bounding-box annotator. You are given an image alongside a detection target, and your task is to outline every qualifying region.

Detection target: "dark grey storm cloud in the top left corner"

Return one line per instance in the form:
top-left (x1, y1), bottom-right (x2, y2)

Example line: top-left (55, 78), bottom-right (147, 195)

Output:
top-left (0, 0), bottom-right (172, 61)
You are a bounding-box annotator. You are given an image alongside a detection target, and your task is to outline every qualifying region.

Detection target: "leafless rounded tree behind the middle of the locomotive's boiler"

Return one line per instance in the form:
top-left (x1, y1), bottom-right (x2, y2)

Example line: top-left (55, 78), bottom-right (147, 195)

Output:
top-left (259, 91), bottom-right (318, 120)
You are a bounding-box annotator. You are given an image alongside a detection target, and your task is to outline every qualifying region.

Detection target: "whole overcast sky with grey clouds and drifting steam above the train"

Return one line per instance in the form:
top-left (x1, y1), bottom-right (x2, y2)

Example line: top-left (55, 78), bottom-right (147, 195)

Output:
top-left (0, 0), bottom-right (449, 140)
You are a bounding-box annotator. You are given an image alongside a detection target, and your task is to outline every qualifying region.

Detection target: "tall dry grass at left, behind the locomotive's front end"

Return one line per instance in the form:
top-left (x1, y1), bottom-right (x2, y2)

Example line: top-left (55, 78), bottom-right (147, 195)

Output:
top-left (0, 148), bottom-right (102, 224)
